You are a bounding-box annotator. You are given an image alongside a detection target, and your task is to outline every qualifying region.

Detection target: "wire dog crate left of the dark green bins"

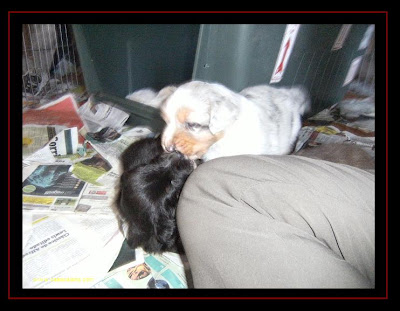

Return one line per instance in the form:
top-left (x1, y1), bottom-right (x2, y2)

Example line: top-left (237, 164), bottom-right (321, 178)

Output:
top-left (22, 24), bottom-right (84, 106)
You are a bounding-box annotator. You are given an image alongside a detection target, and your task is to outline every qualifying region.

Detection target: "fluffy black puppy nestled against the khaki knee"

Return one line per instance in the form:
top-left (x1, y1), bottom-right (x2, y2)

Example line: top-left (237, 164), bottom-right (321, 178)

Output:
top-left (116, 138), bottom-right (196, 253)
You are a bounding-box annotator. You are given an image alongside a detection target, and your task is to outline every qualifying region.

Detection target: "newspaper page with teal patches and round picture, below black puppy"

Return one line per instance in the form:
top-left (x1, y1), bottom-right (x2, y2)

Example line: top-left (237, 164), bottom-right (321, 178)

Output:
top-left (94, 248), bottom-right (188, 289)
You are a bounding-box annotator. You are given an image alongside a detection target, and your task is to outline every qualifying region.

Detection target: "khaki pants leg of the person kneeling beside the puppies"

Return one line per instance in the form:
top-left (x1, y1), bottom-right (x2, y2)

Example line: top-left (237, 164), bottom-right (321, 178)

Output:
top-left (177, 155), bottom-right (375, 288)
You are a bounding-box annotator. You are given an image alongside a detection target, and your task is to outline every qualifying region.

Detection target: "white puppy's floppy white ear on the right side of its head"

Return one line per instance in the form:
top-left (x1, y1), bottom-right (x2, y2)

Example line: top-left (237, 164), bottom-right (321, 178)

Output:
top-left (209, 98), bottom-right (239, 135)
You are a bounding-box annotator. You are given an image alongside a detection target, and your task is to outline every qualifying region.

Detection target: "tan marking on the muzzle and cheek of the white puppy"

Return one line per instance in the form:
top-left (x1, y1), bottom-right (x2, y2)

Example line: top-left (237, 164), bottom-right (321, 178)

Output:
top-left (172, 131), bottom-right (223, 159)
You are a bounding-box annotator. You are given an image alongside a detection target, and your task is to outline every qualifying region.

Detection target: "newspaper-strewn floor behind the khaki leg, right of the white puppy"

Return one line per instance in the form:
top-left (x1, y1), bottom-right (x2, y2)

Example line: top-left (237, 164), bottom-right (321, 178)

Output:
top-left (293, 81), bottom-right (375, 173)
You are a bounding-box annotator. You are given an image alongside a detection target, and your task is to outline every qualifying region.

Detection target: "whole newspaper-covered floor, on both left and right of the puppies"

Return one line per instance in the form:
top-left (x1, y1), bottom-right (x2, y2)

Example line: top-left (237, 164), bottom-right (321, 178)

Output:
top-left (22, 83), bottom-right (375, 288)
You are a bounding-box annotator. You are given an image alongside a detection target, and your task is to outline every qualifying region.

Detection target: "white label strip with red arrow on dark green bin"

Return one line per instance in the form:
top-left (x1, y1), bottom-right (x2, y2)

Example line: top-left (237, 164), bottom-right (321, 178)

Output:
top-left (269, 24), bottom-right (300, 83)
